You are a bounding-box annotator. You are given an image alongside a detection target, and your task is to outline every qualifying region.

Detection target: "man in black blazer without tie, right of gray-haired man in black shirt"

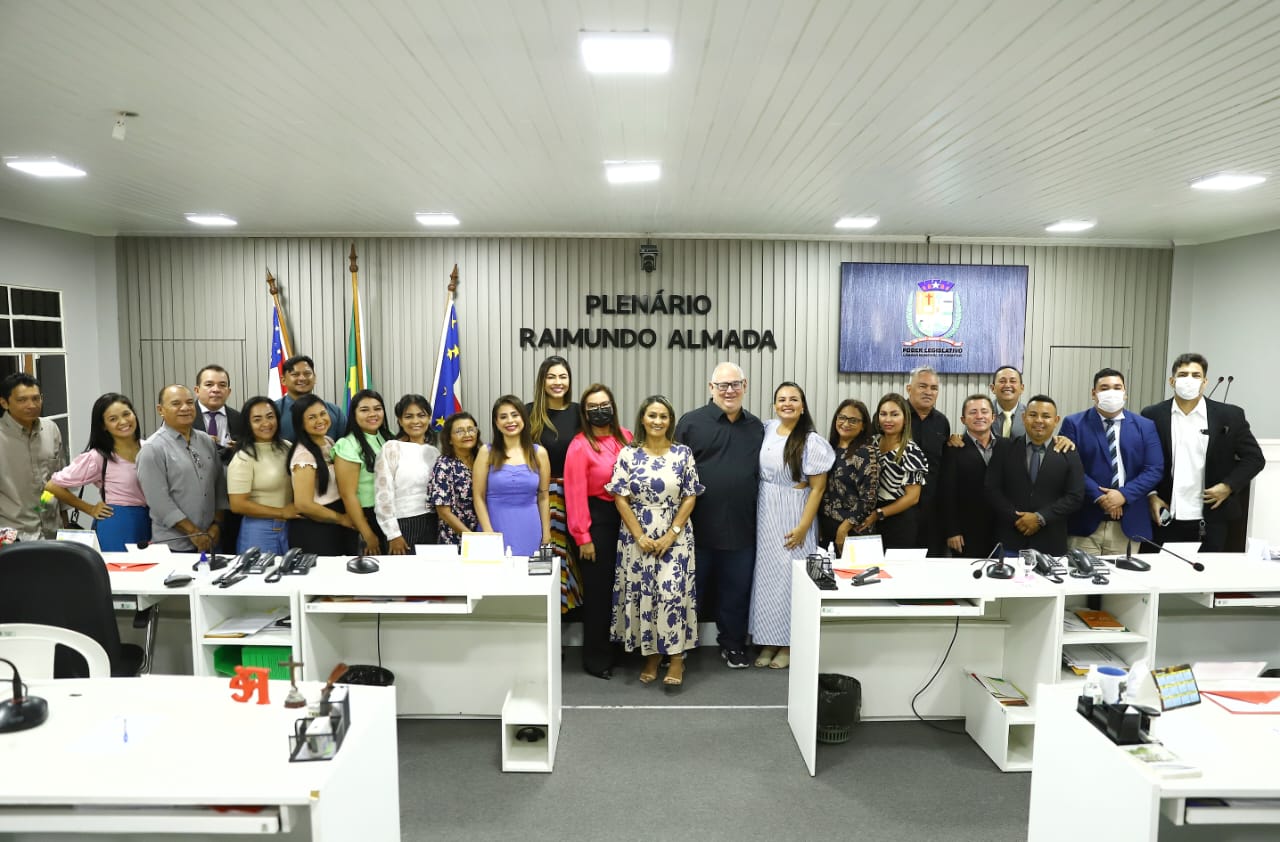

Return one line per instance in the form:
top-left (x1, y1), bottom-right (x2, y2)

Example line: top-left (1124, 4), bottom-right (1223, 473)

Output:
top-left (941, 394), bottom-right (998, 558)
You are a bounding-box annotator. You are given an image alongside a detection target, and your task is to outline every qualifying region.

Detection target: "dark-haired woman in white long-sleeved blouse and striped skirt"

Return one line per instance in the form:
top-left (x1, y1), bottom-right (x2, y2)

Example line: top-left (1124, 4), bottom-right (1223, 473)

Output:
top-left (374, 394), bottom-right (440, 555)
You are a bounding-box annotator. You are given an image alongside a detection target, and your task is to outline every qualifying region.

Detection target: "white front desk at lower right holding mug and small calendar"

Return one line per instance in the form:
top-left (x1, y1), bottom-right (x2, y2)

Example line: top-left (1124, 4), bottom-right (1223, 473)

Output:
top-left (1028, 685), bottom-right (1280, 842)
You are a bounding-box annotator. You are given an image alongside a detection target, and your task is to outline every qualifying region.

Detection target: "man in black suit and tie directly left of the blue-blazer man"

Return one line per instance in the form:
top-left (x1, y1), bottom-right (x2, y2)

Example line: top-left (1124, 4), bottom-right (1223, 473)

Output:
top-left (987, 394), bottom-right (1084, 555)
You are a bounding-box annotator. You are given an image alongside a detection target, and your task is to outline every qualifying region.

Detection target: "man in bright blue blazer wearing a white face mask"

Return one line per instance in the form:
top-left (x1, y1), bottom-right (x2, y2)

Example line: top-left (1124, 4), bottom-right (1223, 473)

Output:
top-left (1061, 369), bottom-right (1165, 555)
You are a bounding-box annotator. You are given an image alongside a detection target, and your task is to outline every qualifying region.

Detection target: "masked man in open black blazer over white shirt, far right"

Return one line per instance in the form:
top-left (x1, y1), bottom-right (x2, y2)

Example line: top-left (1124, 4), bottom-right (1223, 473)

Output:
top-left (1142, 353), bottom-right (1266, 553)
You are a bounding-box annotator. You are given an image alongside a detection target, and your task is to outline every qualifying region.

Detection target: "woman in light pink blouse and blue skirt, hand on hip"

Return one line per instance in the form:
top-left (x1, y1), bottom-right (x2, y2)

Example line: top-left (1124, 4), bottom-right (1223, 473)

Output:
top-left (45, 392), bottom-right (151, 553)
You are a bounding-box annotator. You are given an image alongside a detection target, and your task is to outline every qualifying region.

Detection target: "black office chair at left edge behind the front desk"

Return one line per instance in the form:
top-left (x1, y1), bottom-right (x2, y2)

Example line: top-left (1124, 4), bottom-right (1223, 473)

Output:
top-left (0, 541), bottom-right (145, 678)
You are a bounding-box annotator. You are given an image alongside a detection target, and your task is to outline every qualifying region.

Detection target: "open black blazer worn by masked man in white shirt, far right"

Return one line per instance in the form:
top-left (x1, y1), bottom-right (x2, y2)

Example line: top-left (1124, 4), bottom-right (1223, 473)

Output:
top-left (1142, 398), bottom-right (1267, 521)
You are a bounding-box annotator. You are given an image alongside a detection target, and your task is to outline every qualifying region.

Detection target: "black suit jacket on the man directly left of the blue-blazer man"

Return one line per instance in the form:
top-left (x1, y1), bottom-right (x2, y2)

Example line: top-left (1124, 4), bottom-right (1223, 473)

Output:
top-left (987, 436), bottom-right (1084, 555)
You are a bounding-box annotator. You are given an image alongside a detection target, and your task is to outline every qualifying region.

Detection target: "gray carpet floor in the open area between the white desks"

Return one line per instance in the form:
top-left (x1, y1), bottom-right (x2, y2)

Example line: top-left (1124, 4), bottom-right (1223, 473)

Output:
top-left (399, 649), bottom-right (1030, 842)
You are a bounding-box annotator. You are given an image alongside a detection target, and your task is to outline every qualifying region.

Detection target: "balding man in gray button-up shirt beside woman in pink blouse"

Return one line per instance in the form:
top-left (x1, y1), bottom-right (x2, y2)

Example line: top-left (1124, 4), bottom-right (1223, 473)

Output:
top-left (137, 385), bottom-right (227, 553)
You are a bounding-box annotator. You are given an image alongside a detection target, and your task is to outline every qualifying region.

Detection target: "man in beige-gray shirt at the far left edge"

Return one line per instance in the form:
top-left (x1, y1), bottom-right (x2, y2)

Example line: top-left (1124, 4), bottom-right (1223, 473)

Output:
top-left (0, 372), bottom-right (67, 541)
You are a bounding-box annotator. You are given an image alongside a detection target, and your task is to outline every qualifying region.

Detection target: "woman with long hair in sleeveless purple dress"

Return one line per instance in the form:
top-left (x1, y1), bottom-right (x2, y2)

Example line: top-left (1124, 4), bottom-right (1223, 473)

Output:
top-left (472, 394), bottom-right (552, 555)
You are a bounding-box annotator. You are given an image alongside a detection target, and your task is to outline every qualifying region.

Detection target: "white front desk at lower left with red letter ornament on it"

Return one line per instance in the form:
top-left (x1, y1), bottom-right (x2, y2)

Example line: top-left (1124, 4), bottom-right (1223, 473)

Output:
top-left (0, 676), bottom-right (399, 842)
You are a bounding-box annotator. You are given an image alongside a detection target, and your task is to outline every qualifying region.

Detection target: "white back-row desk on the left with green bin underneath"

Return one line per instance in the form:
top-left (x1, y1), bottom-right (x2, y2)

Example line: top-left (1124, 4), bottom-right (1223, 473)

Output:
top-left (99, 554), bottom-right (561, 772)
